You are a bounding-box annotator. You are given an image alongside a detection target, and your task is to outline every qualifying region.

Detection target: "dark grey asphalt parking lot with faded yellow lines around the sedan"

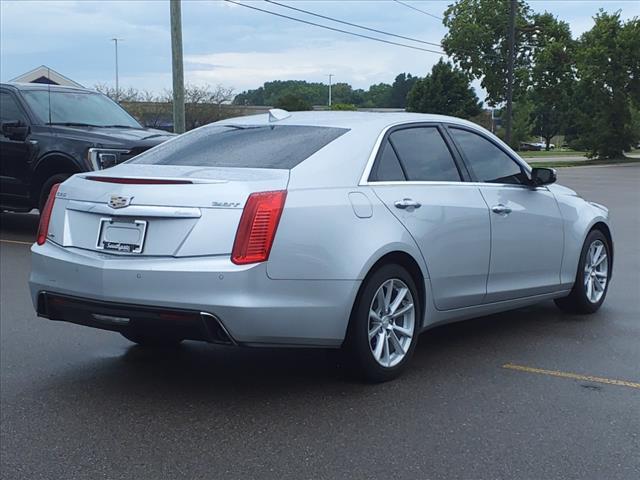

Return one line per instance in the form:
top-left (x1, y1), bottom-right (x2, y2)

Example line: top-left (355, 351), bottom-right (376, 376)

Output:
top-left (0, 165), bottom-right (640, 480)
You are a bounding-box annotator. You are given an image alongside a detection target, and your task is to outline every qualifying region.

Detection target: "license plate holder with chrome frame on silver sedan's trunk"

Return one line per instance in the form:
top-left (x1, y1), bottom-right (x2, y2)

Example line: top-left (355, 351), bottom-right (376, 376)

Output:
top-left (96, 217), bottom-right (147, 253)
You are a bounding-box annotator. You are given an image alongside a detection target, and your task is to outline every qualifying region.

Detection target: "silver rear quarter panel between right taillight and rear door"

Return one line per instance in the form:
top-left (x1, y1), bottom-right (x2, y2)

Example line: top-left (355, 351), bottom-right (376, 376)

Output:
top-left (267, 187), bottom-right (428, 280)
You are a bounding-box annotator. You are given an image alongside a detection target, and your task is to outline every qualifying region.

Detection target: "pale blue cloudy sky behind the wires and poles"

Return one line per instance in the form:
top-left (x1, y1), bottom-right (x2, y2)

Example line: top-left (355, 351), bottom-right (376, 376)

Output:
top-left (0, 0), bottom-right (640, 99)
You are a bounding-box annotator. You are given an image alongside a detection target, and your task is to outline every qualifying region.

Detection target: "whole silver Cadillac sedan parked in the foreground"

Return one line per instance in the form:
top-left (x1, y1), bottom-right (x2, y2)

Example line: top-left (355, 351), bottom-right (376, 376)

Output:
top-left (29, 110), bottom-right (613, 381)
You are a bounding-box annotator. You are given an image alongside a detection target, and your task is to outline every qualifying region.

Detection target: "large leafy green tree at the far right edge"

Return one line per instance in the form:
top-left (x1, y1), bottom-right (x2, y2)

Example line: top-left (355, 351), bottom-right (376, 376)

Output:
top-left (575, 10), bottom-right (640, 158)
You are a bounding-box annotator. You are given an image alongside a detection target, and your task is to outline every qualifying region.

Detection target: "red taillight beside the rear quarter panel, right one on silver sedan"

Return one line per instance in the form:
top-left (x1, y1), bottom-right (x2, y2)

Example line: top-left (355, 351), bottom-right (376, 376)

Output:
top-left (231, 190), bottom-right (287, 265)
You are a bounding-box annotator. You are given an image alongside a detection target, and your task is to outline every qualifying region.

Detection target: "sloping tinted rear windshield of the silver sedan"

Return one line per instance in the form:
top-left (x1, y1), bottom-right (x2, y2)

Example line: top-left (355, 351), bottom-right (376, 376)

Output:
top-left (129, 125), bottom-right (348, 169)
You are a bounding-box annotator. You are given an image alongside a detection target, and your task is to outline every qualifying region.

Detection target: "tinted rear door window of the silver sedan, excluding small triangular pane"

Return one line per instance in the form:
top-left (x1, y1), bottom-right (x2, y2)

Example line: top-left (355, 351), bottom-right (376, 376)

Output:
top-left (389, 127), bottom-right (461, 182)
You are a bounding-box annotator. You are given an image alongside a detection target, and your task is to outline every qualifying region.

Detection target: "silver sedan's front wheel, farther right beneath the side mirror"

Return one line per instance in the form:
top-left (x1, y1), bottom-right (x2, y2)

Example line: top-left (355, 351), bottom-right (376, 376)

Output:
top-left (555, 230), bottom-right (612, 314)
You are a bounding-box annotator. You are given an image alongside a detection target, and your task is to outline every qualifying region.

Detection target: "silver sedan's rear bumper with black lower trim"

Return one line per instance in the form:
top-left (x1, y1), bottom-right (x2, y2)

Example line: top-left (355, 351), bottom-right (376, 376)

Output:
top-left (29, 242), bottom-right (360, 347)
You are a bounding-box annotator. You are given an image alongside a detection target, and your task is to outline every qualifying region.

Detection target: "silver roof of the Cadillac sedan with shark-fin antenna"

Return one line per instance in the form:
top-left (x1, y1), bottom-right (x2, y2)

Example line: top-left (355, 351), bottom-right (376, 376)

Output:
top-left (217, 111), bottom-right (484, 131)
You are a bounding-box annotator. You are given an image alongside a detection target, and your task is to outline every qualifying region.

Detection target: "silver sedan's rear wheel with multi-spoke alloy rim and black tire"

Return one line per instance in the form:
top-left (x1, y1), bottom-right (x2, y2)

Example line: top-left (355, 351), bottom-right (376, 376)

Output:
top-left (345, 264), bottom-right (422, 383)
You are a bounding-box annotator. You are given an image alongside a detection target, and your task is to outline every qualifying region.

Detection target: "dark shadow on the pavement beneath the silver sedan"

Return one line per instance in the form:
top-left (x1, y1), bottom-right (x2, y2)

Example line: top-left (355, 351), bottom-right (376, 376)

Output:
top-left (32, 302), bottom-right (592, 405)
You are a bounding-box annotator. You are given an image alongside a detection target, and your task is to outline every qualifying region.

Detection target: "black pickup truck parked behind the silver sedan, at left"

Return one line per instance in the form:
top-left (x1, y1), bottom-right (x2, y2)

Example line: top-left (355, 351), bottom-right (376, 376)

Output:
top-left (0, 83), bottom-right (173, 212)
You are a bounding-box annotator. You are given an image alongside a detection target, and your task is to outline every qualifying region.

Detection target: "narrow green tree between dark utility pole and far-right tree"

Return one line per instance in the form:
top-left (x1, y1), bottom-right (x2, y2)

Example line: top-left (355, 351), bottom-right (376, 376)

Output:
top-left (528, 13), bottom-right (576, 150)
